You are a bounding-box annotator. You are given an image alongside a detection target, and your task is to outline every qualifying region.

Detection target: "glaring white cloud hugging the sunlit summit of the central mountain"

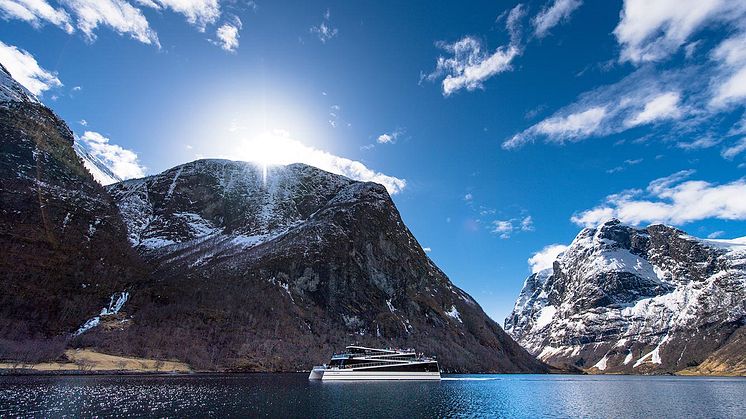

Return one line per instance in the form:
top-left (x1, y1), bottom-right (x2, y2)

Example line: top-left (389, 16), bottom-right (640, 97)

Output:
top-left (218, 130), bottom-right (407, 195)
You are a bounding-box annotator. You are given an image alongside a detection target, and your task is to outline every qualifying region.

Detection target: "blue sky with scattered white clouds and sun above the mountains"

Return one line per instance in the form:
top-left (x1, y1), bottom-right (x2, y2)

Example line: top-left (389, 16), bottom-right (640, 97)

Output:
top-left (0, 0), bottom-right (746, 322)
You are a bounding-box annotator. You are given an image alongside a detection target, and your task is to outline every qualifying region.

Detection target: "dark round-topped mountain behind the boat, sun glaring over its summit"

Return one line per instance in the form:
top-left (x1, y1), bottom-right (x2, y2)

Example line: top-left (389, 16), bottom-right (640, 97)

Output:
top-left (90, 160), bottom-right (546, 372)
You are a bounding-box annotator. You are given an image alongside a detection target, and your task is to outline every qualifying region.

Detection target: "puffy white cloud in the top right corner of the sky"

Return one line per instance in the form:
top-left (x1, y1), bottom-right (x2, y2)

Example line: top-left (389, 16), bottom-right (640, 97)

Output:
top-left (614, 0), bottom-right (746, 63)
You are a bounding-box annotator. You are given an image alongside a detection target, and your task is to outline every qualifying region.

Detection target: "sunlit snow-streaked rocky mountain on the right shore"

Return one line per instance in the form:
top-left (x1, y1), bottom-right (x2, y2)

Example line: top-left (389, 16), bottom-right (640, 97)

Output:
top-left (505, 220), bottom-right (746, 374)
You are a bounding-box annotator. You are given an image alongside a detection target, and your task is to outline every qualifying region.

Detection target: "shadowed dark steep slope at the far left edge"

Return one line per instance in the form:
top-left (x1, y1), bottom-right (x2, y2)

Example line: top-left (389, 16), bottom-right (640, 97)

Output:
top-left (0, 66), bottom-right (146, 360)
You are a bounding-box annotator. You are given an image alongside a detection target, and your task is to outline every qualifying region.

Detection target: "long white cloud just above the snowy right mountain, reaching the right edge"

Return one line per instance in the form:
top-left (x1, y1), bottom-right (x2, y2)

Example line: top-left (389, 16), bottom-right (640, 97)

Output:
top-left (571, 170), bottom-right (746, 227)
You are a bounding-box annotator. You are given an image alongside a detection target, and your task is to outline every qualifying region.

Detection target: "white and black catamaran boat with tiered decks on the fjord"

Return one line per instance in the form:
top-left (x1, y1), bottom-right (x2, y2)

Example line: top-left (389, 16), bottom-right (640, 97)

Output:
top-left (308, 346), bottom-right (440, 381)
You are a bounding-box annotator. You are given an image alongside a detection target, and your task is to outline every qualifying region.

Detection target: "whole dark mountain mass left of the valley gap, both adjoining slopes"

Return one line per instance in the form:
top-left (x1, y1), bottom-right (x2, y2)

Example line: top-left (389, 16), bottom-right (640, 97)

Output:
top-left (0, 64), bottom-right (548, 372)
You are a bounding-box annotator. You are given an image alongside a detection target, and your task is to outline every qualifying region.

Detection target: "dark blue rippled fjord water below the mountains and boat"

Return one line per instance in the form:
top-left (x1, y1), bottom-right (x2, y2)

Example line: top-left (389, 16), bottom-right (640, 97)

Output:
top-left (0, 374), bottom-right (746, 418)
